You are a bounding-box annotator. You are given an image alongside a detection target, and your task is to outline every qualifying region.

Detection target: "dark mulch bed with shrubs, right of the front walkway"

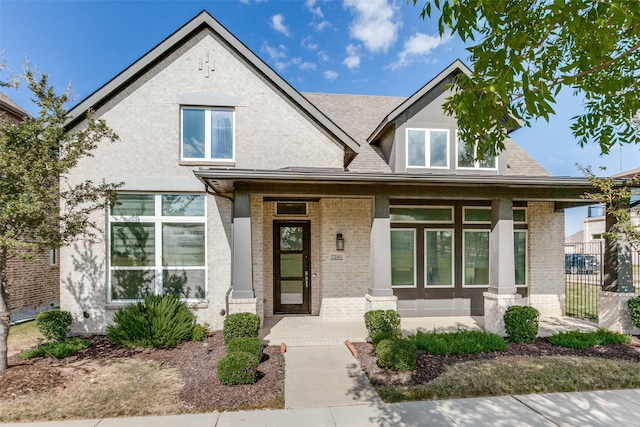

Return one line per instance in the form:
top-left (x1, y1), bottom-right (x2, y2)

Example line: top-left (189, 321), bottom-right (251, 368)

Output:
top-left (353, 336), bottom-right (640, 385)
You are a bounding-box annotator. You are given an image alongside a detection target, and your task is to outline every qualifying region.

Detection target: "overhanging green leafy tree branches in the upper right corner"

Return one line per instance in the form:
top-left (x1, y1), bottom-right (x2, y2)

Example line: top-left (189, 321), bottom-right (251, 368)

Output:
top-left (407, 0), bottom-right (640, 159)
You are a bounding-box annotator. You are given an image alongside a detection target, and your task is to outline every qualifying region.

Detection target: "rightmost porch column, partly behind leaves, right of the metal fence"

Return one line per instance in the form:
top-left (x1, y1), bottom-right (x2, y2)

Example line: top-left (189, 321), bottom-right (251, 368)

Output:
top-left (598, 200), bottom-right (640, 334)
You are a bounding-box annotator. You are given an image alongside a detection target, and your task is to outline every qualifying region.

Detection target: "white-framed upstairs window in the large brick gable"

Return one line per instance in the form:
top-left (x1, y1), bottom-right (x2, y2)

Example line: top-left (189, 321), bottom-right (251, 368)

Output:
top-left (181, 107), bottom-right (234, 161)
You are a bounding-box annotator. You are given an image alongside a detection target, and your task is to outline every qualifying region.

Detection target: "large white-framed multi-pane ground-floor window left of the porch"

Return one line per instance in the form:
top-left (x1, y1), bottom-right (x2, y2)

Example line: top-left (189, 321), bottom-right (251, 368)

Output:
top-left (109, 194), bottom-right (206, 301)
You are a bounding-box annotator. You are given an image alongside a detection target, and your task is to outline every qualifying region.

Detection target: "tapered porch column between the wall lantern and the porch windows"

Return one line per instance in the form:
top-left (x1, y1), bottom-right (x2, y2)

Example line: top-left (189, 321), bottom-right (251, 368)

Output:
top-left (365, 196), bottom-right (397, 311)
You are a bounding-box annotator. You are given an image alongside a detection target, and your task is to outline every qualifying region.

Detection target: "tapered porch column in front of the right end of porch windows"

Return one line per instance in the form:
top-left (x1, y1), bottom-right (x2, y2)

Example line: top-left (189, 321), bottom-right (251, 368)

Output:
top-left (484, 199), bottom-right (522, 335)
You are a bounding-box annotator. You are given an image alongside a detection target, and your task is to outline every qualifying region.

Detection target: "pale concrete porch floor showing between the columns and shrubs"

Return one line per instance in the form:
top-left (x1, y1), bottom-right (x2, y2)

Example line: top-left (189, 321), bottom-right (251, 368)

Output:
top-left (260, 316), bottom-right (598, 347)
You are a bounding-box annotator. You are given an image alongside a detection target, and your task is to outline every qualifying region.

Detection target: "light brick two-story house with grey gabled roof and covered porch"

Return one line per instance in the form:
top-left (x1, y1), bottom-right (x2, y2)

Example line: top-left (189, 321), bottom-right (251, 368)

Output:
top-left (61, 12), bottom-right (589, 332)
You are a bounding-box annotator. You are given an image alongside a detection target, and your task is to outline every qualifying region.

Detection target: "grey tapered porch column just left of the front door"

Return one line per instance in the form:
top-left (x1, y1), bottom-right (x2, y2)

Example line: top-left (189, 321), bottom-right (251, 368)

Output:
top-left (231, 191), bottom-right (255, 299)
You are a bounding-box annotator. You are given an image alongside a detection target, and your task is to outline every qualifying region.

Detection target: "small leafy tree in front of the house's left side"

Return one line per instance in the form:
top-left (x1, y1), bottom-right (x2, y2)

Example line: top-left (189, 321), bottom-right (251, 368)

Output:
top-left (0, 69), bottom-right (119, 371)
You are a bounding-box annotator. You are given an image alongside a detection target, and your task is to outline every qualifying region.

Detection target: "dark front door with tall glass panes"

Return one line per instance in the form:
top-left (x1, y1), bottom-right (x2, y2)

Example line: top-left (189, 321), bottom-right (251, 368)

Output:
top-left (273, 221), bottom-right (311, 314)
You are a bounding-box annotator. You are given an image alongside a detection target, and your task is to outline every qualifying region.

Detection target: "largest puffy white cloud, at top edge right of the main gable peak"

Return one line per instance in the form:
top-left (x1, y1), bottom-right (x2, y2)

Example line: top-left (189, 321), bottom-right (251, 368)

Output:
top-left (344, 0), bottom-right (402, 53)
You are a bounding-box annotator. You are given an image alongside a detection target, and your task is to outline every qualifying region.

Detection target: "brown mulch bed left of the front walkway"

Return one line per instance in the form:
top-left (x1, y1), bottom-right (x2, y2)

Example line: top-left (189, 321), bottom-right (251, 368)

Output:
top-left (0, 331), bottom-right (284, 411)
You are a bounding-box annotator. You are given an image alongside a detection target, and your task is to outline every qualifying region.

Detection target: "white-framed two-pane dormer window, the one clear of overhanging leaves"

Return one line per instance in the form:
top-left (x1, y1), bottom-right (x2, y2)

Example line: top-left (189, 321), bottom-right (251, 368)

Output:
top-left (407, 129), bottom-right (449, 168)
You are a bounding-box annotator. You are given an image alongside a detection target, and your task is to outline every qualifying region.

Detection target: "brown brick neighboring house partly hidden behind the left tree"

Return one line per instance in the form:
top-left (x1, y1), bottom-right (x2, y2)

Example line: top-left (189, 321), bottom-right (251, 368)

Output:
top-left (0, 92), bottom-right (60, 321)
